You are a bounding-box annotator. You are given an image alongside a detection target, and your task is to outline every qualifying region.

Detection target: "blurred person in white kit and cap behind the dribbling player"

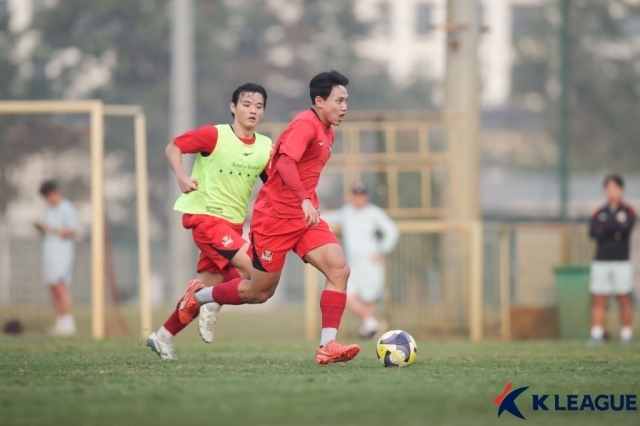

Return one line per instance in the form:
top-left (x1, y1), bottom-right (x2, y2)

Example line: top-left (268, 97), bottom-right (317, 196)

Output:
top-left (322, 183), bottom-right (399, 339)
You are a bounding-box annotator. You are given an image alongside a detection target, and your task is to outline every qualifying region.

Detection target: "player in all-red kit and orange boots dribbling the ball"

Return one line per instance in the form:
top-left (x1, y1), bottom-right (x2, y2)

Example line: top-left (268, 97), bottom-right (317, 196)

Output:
top-left (181, 70), bottom-right (360, 364)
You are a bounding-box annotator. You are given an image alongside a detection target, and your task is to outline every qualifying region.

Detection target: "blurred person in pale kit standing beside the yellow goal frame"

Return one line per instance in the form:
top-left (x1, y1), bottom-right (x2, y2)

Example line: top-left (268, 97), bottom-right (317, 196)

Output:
top-left (35, 180), bottom-right (78, 336)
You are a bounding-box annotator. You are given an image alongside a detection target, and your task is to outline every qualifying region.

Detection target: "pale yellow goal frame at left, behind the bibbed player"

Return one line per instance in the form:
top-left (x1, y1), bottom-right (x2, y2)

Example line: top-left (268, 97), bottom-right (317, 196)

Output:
top-left (0, 100), bottom-right (151, 340)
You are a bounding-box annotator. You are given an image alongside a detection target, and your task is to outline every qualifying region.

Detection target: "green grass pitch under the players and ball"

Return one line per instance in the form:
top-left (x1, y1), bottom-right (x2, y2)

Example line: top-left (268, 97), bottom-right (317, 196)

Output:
top-left (0, 317), bottom-right (640, 426)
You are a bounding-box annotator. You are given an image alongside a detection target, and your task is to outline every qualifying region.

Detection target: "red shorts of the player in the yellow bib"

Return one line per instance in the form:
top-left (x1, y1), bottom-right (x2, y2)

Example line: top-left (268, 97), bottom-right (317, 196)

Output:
top-left (182, 214), bottom-right (246, 275)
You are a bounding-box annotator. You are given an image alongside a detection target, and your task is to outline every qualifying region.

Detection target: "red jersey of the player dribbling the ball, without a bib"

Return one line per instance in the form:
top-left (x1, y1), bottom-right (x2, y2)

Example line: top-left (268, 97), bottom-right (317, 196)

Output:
top-left (254, 109), bottom-right (335, 218)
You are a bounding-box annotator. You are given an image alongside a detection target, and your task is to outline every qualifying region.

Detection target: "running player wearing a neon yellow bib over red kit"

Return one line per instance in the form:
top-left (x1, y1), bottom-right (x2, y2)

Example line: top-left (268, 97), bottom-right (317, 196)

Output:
top-left (147, 83), bottom-right (271, 359)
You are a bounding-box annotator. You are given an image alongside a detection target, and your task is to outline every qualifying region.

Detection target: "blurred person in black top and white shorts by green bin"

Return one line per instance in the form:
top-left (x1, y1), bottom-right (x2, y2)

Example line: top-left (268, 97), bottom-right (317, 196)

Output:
top-left (589, 174), bottom-right (636, 345)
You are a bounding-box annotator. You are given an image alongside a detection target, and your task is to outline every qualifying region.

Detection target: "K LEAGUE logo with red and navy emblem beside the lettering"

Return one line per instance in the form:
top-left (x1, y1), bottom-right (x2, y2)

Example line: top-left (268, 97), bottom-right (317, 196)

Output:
top-left (493, 382), bottom-right (638, 420)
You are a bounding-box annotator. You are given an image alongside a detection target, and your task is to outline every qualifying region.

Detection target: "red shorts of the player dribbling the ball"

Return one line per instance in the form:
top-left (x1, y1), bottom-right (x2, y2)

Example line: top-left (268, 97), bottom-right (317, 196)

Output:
top-left (249, 210), bottom-right (340, 272)
